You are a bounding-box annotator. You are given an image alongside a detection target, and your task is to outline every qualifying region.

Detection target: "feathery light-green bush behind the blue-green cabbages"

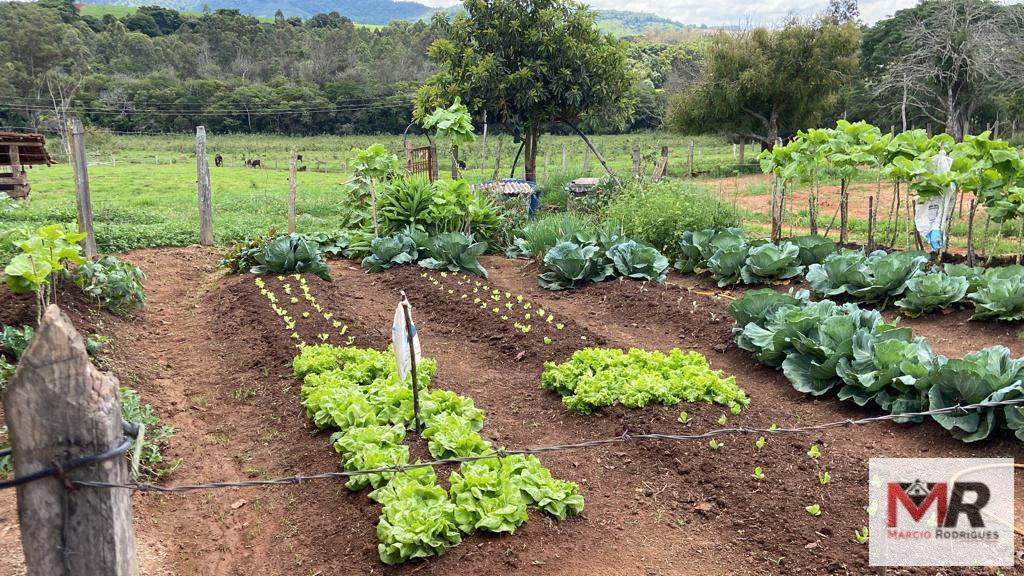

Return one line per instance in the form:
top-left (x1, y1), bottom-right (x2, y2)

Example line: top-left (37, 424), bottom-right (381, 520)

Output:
top-left (605, 182), bottom-right (736, 257)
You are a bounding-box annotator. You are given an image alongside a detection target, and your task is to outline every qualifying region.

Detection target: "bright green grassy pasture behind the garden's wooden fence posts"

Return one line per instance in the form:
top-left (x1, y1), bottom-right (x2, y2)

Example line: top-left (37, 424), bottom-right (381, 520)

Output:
top-left (5, 132), bottom-right (750, 251)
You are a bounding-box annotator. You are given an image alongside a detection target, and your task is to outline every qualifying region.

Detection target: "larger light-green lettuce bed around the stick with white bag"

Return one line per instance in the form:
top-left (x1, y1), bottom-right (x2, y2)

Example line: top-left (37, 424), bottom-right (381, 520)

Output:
top-left (293, 344), bottom-right (584, 564)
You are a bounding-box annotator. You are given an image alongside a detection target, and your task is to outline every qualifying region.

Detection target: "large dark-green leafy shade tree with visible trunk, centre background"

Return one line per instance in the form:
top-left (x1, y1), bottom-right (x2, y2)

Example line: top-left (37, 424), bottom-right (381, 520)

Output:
top-left (415, 0), bottom-right (637, 180)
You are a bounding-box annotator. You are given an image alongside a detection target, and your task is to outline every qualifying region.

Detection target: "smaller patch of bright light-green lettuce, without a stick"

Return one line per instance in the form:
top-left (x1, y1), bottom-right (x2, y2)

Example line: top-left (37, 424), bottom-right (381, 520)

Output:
top-left (541, 348), bottom-right (750, 414)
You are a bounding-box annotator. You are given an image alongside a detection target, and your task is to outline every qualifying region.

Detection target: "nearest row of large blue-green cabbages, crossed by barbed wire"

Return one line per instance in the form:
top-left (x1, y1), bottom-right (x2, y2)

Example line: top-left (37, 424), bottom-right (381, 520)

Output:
top-left (729, 289), bottom-right (1024, 442)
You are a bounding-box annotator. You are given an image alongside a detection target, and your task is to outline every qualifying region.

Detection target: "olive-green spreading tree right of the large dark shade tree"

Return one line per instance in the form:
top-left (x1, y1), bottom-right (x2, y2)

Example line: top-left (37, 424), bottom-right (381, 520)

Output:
top-left (669, 17), bottom-right (860, 147)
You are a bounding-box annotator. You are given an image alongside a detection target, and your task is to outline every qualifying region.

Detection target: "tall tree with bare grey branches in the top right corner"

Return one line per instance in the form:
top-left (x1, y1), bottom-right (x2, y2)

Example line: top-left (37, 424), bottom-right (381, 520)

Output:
top-left (864, 0), bottom-right (1024, 140)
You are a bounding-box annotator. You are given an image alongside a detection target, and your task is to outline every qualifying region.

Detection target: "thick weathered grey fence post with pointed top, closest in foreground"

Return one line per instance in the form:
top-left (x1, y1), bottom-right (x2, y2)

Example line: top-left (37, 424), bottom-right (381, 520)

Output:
top-left (4, 304), bottom-right (138, 576)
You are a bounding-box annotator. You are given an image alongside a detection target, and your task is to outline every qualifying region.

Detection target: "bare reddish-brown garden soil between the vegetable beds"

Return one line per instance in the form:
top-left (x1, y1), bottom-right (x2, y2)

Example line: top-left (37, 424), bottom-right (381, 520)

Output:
top-left (0, 248), bottom-right (1024, 575)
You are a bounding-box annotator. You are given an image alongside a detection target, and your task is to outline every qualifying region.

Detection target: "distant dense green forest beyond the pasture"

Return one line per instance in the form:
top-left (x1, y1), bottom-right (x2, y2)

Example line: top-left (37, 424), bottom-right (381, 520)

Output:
top-left (0, 0), bottom-right (698, 134)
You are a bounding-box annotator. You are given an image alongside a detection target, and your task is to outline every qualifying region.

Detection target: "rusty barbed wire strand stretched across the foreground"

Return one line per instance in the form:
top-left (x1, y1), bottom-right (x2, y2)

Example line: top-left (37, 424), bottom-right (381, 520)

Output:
top-left (6, 398), bottom-right (1024, 493)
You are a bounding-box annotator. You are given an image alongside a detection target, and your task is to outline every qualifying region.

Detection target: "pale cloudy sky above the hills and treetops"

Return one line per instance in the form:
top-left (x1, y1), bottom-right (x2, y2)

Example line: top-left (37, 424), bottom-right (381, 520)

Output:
top-left (419, 0), bottom-right (916, 26)
